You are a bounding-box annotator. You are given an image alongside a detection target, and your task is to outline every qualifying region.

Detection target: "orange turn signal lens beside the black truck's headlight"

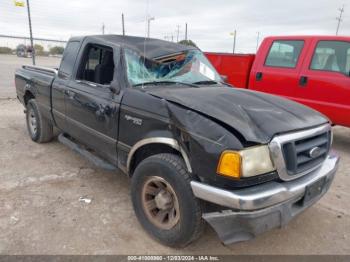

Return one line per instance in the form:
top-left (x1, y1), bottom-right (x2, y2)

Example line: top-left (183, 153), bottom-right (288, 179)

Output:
top-left (217, 151), bottom-right (241, 178)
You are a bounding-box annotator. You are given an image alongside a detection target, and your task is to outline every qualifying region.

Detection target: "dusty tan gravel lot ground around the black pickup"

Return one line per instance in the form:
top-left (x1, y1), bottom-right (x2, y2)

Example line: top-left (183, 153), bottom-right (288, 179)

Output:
top-left (0, 56), bottom-right (350, 254)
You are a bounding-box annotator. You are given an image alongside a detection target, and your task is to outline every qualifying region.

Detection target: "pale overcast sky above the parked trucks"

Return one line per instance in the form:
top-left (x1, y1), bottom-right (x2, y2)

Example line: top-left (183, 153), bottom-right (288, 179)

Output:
top-left (0, 0), bottom-right (350, 53)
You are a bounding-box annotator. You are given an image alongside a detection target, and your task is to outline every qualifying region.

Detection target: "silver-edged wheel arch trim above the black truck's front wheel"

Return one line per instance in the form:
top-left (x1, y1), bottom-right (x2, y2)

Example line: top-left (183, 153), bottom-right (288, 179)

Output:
top-left (126, 137), bottom-right (192, 176)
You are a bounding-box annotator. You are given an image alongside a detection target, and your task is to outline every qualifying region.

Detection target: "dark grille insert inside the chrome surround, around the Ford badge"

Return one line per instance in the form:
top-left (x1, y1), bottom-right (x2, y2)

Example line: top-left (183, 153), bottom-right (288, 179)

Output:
top-left (282, 131), bottom-right (331, 176)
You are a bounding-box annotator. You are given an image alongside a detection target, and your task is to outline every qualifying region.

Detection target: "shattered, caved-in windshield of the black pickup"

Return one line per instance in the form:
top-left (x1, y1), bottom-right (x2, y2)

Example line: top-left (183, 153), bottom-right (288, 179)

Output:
top-left (125, 49), bottom-right (221, 86)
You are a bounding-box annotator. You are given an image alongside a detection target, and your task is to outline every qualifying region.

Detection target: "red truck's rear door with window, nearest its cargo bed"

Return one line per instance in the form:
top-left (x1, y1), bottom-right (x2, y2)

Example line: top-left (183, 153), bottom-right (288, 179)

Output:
top-left (249, 38), bottom-right (307, 98)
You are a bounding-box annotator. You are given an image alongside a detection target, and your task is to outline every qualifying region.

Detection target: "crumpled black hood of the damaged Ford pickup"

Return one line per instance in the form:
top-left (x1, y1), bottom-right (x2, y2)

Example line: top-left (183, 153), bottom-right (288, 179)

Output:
top-left (146, 86), bottom-right (328, 143)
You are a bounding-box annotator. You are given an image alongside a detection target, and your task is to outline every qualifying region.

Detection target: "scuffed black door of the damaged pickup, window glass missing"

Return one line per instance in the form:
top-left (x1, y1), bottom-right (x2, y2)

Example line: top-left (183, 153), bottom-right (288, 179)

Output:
top-left (65, 43), bottom-right (121, 165)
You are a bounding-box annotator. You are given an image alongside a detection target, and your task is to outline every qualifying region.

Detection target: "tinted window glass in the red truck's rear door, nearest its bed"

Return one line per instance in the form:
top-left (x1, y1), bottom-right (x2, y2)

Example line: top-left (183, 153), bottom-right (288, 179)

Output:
top-left (265, 40), bottom-right (304, 68)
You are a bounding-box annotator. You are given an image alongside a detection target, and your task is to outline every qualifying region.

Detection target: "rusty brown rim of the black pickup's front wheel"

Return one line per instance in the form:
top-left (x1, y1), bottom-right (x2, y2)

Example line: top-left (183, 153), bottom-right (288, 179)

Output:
top-left (142, 176), bottom-right (180, 229)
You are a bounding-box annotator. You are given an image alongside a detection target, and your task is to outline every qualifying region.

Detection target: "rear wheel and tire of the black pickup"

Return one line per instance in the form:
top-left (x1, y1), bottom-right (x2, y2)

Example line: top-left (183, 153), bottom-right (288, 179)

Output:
top-left (26, 99), bottom-right (53, 143)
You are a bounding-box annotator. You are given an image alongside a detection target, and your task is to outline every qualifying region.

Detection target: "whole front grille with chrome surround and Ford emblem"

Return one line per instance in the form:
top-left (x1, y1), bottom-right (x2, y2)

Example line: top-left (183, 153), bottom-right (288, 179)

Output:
top-left (269, 124), bottom-right (332, 181)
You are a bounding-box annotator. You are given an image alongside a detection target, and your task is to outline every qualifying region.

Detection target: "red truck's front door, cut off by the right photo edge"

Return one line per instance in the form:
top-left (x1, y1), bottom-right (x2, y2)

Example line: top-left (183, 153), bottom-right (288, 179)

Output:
top-left (295, 39), bottom-right (350, 126)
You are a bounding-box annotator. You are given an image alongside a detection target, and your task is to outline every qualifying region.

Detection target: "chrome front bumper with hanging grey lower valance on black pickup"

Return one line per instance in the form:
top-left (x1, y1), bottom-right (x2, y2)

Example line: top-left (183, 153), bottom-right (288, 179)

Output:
top-left (191, 153), bottom-right (339, 244)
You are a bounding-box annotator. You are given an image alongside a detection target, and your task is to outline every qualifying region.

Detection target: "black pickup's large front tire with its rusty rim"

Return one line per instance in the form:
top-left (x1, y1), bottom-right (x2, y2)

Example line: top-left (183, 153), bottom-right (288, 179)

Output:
top-left (131, 153), bottom-right (204, 248)
